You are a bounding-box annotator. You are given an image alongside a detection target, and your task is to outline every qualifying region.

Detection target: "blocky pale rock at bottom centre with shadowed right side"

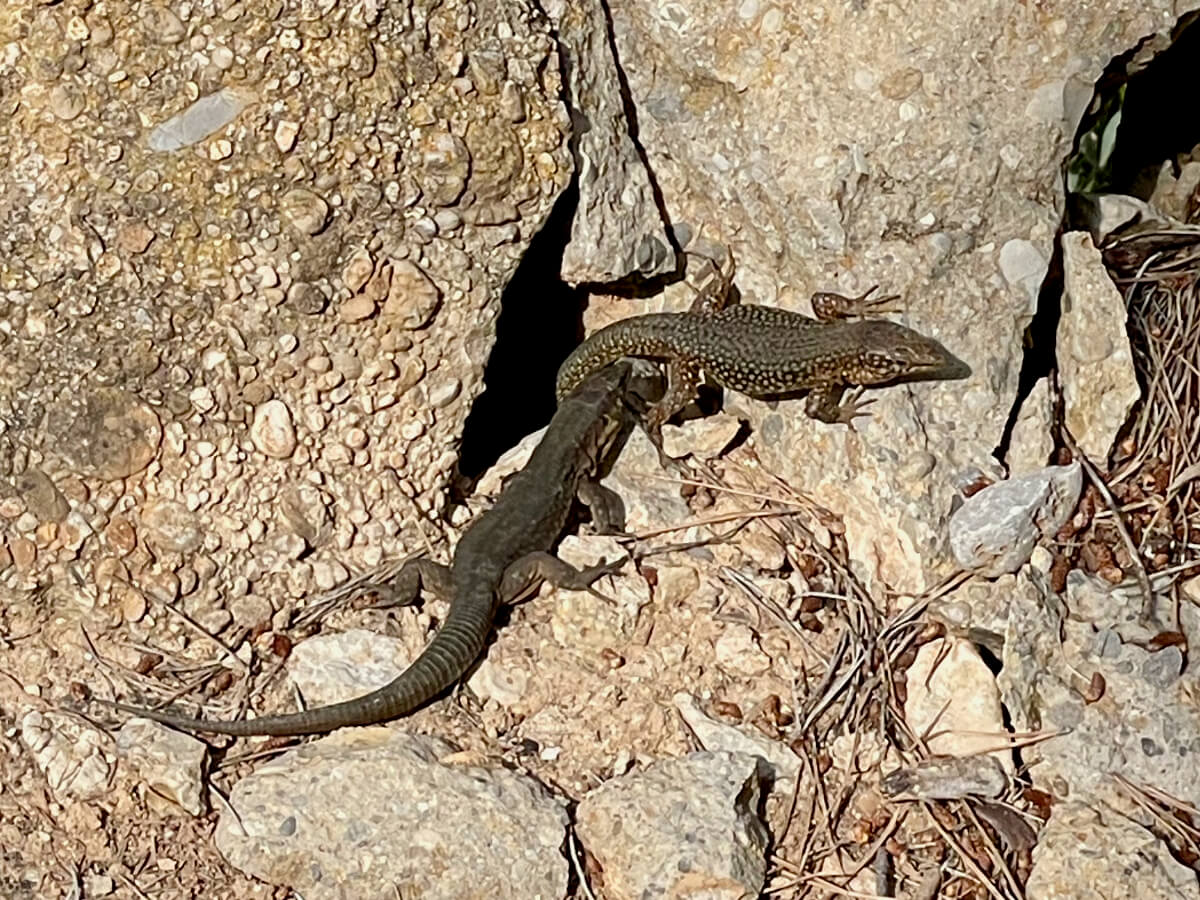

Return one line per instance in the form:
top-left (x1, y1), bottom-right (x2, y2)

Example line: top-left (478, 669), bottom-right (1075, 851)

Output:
top-left (576, 751), bottom-right (769, 900)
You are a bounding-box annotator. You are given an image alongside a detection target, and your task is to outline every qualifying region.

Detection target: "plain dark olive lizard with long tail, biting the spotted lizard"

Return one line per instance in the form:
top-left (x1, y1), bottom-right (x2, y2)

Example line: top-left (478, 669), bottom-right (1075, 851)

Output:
top-left (112, 360), bottom-right (662, 736)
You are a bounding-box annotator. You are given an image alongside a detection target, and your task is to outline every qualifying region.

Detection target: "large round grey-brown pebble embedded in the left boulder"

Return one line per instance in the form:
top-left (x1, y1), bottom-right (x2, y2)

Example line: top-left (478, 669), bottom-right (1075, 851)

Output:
top-left (49, 388), bottom-right (162, 481)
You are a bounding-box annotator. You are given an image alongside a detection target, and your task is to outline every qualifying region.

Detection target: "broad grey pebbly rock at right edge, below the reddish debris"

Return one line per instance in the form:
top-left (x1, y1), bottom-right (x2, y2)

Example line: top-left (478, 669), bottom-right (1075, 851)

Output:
top-left (998, 572), bottom-right (1200, 806)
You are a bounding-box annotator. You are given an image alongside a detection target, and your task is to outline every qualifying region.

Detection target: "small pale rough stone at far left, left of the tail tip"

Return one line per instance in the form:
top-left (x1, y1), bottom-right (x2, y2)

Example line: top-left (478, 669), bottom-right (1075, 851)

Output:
top-left (20, 712), bottom-right (113, 800)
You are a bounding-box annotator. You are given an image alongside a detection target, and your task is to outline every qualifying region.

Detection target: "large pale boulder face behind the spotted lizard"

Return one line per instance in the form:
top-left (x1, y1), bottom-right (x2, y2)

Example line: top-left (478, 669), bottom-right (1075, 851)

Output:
top-left (595, 0), bottom-right (1182, 590)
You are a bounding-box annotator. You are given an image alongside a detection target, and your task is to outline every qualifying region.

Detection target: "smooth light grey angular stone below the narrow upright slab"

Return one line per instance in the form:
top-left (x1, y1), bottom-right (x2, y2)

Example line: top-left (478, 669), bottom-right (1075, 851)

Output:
top-left (950, 462), bottom-right (1084, 577)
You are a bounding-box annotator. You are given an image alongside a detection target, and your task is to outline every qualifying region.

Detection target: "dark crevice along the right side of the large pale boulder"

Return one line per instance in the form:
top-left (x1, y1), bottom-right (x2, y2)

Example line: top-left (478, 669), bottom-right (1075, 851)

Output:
top-left (995, 14), bottom-right (1200, 468)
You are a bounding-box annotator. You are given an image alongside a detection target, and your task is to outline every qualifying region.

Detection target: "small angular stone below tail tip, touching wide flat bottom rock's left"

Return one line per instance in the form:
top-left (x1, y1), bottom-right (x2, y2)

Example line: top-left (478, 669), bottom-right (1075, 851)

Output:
top-left (116, 718), bottom-right (208, 816)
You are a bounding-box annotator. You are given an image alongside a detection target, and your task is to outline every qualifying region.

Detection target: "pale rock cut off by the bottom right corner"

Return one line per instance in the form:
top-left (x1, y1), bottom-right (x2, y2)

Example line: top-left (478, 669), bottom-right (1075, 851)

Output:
top-left (1025, 800), bottom-right (1200, 900)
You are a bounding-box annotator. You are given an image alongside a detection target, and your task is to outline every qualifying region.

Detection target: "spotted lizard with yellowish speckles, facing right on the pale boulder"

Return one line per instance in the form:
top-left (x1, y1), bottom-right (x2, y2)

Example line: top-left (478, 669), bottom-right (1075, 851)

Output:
top-left (556, 260), bottom-right (971, 427)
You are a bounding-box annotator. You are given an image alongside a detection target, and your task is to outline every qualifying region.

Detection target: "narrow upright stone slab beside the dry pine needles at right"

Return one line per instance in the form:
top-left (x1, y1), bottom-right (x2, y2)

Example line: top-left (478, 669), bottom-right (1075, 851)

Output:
top-left (1055, 232), bottom-right (1141, 469)
